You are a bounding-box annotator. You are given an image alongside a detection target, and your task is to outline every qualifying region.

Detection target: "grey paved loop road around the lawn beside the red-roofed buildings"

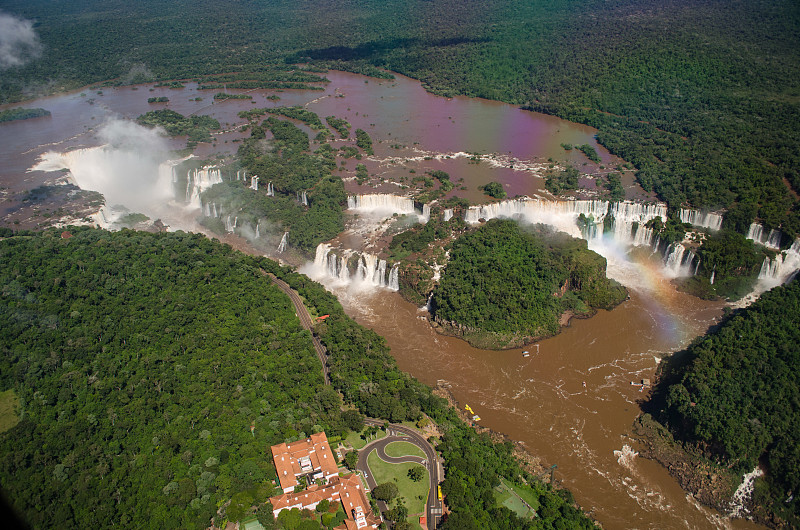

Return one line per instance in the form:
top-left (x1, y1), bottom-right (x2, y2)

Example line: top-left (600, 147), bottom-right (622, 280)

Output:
top-left (358, 418), bottom-right (442, 530)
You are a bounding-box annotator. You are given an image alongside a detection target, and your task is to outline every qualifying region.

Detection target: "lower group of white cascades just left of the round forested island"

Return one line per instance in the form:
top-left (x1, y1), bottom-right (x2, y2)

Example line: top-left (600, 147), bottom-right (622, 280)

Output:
top-left (312, 243), bottom-right (400, 291)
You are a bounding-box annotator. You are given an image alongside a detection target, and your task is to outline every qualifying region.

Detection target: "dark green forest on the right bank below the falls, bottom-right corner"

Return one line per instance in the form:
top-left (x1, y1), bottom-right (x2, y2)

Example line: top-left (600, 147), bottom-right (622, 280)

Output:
top-left (644, 281), bottom-right (800, 527)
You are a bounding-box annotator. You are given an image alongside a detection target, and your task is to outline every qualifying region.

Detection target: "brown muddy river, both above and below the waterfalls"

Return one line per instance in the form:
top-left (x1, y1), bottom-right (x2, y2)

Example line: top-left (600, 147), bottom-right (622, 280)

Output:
top-left (0, 72), bottom-right (756, 529)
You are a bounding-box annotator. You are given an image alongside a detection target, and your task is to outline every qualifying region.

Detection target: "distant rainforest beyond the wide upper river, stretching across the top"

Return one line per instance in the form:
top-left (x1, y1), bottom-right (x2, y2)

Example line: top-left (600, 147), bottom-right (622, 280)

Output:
top-left (0, 0), bottom-right (800, 241)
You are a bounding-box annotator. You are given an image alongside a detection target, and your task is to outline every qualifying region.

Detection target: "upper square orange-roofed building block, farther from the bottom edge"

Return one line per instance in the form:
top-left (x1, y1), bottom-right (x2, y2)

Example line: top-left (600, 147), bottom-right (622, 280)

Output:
top-left (272, 432), bottom-right (339, 493)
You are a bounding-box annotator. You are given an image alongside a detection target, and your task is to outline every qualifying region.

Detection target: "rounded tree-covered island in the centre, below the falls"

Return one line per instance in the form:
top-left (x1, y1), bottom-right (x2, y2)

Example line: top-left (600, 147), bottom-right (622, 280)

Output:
top-left (431, 219), bottom-right (627, 348)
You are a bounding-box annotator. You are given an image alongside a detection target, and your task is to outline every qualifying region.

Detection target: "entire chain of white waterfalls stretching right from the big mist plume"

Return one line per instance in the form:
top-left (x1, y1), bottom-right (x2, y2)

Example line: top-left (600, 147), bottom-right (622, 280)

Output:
top-left (181, 163), bottom-right (800, 289)
